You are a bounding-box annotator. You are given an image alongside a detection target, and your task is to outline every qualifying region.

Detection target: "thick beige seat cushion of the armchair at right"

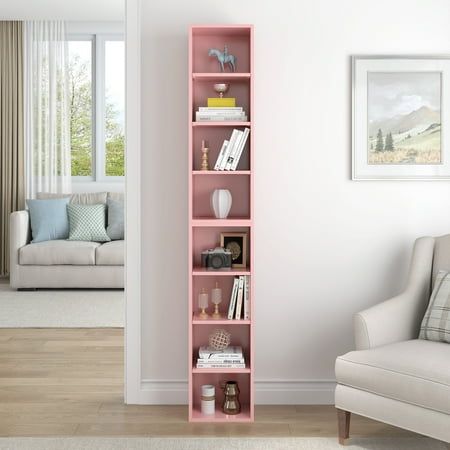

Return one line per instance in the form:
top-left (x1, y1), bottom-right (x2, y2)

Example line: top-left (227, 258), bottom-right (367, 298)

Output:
top-left (336, 339), bottom-right (450, 414)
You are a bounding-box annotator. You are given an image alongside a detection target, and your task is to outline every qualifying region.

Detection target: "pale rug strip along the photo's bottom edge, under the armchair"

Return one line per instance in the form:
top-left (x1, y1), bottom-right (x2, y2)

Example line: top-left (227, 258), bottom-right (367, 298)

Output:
top-left (0, 437), bottom-right (447, 450)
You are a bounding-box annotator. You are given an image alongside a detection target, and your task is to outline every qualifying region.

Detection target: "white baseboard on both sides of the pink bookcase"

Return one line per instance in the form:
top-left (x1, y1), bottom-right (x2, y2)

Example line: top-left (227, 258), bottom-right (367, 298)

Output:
top-left (138, 380), bottom-right (336, 405)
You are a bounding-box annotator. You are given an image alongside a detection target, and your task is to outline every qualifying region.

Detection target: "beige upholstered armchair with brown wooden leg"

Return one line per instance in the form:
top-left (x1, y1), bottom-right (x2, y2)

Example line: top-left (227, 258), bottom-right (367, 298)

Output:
top-left (335, 235), bottom-right (450, 444)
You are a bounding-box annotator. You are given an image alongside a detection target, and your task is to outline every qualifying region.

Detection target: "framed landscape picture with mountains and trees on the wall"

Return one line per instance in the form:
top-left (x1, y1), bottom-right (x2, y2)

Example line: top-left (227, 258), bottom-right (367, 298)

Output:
top-left (352, 56), bottom-right (450, 180)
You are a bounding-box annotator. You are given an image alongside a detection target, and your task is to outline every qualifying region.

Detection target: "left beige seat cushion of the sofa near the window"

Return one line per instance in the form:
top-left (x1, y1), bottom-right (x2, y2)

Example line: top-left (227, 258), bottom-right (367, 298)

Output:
top-left (19, 240), bottom-right (100, 266)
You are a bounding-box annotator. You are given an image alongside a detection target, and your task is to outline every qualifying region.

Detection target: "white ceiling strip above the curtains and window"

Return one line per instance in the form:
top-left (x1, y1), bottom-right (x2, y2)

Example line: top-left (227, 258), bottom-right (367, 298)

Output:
top-left (0, 0), bottom-right (125, 21)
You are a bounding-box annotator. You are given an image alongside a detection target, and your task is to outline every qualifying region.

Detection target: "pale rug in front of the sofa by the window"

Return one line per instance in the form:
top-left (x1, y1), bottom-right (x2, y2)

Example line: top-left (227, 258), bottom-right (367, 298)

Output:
top-left (0, 282), bottom-right (125, 328)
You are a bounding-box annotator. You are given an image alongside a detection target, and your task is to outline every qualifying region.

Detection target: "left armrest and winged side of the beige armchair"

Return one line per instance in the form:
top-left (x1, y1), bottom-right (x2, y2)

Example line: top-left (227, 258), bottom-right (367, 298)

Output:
top-left (353, 237), bottom-right (434, 350)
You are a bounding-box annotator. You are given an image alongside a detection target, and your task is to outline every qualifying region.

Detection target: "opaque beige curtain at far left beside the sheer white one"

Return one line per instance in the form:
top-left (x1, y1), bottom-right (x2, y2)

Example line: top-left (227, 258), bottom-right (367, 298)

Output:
top-left (0, 21), bottom-right (25, 276)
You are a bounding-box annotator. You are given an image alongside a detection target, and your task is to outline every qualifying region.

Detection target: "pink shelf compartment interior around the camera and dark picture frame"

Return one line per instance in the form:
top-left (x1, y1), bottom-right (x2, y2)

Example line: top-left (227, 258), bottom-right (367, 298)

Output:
top-left (192, 227), bottom-right (251, 268)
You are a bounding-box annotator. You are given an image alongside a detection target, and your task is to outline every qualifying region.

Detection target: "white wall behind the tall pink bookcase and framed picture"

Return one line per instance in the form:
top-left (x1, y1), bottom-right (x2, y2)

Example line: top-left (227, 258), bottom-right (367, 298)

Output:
top-left (141, 0), bottom-right (450, 402)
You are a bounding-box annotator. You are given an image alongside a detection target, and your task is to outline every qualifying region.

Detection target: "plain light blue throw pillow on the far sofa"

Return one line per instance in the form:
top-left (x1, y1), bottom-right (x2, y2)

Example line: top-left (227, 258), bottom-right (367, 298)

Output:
top-left (27, 198), bottom-right (70, 242)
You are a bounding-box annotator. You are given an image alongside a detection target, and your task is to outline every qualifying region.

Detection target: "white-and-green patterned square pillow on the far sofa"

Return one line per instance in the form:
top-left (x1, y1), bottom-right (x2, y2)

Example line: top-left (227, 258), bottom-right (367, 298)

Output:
top-left (67, 204), bottom-right (111, 242)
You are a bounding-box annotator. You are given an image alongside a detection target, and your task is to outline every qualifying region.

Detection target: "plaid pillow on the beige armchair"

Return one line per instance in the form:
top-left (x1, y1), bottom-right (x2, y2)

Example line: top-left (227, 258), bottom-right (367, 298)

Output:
top-left (419, 270), bottom-right (450, 344)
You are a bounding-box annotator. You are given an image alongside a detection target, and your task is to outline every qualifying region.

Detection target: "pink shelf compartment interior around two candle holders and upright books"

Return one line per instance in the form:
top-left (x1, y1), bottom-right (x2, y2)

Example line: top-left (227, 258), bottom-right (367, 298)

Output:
top-left (192, 275), bottom-right (251, 325)
